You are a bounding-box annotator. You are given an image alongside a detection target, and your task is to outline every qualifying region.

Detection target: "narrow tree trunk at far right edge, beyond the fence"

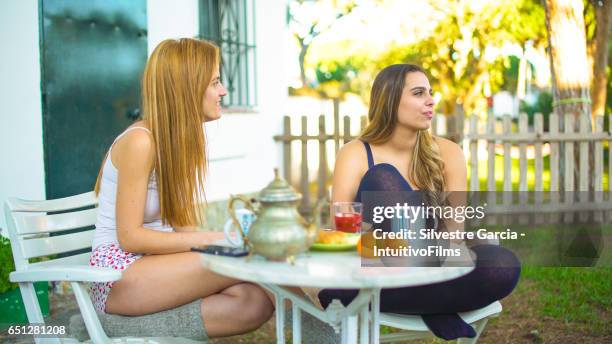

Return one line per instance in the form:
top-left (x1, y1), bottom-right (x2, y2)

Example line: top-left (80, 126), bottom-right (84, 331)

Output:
top-left (591, 0), bottom-right (612, 118)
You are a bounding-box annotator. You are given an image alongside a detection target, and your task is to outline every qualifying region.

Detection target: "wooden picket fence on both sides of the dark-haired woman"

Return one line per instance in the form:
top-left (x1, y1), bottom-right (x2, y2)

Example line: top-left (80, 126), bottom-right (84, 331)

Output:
top-left (274, 114), bottom-right (612, 222)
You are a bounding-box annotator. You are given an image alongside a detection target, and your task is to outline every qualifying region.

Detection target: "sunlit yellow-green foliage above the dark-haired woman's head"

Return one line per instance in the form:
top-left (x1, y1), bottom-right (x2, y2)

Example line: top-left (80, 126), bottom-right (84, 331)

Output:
top-left (320, 0), bottom-right (546, 114)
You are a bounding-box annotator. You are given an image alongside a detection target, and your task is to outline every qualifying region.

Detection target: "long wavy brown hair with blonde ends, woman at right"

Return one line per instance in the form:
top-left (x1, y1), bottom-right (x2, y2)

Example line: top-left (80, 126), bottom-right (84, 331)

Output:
top-left (360, 64), bottom-right (445, 192)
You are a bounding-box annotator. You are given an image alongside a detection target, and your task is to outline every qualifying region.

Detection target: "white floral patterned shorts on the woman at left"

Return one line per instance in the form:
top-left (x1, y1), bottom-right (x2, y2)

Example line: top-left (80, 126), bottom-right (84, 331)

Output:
top-left (89, 243), bottom-right (142, 312)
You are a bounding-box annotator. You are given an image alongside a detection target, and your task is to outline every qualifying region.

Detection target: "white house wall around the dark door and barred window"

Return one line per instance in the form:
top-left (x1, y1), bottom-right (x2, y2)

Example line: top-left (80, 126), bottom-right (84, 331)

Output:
top-left (0, 0), bottom-right (287, 234)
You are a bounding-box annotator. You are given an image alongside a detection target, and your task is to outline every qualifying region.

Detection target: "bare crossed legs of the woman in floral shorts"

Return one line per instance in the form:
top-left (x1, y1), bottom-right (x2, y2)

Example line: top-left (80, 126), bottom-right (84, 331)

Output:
top-left (106, 252), bottom-right (273, 337)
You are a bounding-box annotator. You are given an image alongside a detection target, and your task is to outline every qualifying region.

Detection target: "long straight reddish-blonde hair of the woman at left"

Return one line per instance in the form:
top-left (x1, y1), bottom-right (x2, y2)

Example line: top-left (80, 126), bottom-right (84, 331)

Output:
top-left (95, 38), bottom-right (219, 227)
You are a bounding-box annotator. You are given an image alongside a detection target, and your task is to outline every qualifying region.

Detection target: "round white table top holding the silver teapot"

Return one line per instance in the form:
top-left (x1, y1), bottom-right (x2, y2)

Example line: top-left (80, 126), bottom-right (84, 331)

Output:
top-left (201, 251), bottom-right (473, 289)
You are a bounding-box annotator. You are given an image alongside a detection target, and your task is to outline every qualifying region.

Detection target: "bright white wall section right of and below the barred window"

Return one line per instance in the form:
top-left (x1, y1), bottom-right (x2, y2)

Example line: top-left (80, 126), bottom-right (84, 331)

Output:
top-left (206, 1), bottom-right (287, 201)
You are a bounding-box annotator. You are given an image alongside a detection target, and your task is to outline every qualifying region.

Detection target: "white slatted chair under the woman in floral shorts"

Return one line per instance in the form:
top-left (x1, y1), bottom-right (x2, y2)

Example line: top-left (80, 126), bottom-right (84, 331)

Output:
top-left (4, 192), bottom-right (203, 344)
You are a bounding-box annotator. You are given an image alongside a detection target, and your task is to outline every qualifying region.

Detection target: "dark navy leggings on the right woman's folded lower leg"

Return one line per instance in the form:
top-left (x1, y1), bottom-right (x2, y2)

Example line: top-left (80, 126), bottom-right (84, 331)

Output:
top-left (319, 245), bottom-right (521, 315)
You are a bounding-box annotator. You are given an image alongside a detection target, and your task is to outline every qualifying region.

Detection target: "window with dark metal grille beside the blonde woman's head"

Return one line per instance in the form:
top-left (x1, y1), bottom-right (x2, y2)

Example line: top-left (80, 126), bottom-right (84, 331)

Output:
top-left (199, 0), bottom-right (257, 109)
